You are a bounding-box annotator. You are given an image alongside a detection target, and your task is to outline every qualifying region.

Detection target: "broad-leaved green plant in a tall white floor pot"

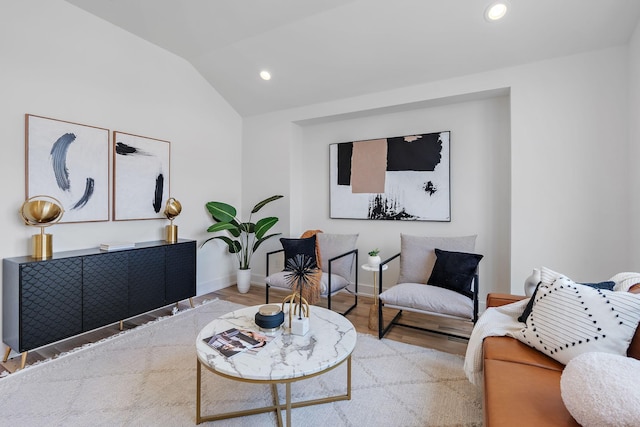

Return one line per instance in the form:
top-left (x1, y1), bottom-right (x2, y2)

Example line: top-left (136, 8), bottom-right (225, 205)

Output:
top-left (201, 195), bottom-right (283, 293)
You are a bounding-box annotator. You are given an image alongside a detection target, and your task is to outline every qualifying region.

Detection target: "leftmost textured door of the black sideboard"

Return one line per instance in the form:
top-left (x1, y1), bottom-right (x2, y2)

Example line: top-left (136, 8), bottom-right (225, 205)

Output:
top-left (18, 258), bottom-right (82, 352)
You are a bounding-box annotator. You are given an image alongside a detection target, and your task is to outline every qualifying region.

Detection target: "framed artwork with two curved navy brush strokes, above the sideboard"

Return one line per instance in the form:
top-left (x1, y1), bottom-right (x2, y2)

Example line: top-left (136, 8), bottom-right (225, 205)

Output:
top-left (25, 114), bottom-right (109, 223)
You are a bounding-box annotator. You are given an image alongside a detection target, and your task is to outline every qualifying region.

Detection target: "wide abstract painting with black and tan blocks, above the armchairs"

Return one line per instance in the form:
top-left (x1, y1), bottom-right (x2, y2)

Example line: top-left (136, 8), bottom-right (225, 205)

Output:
top-left (329, 131), bottom-right (451, 221)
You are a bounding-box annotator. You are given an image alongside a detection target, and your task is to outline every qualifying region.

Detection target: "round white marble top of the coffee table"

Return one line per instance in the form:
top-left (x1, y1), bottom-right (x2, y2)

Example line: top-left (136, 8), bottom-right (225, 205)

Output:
top-left (196, 305), bottom-right (357, 382)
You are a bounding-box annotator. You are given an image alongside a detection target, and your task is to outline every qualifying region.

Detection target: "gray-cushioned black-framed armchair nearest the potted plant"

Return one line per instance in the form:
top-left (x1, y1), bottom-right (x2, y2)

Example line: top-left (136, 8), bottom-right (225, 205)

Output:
top-left (265, 232), bottom-right (358, 315)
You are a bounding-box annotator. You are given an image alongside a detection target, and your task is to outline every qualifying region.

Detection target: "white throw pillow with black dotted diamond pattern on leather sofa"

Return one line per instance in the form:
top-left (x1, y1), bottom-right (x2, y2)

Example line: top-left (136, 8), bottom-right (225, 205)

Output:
top-left (515, 277), bottom-right (640, 364)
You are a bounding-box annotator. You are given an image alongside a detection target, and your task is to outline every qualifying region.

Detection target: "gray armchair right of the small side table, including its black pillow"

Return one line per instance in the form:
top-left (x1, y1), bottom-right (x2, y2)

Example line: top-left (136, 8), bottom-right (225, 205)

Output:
top-left (378, 234), bottom-right (482, 338)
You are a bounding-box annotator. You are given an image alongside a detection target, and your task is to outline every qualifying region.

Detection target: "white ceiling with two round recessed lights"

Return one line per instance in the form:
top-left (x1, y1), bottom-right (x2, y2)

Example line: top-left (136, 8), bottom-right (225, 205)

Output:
top-left (66, 0), bottom-right (640, 116)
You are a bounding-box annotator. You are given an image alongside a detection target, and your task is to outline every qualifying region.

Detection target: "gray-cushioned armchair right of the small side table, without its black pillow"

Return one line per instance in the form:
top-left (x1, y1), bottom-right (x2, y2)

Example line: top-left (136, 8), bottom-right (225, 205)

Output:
top-left (378, 234), bottom-right (479, 339)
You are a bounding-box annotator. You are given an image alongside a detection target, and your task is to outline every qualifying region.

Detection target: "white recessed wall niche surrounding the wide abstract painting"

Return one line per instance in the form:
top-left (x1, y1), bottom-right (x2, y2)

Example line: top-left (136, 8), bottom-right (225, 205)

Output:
top-left (291, 96), bottom-right (510, 302)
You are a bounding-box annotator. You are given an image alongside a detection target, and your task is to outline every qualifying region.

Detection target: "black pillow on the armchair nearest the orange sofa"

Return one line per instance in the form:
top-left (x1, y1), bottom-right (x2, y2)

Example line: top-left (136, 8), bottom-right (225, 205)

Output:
top-left (427, 248), bottom-right (483, 298)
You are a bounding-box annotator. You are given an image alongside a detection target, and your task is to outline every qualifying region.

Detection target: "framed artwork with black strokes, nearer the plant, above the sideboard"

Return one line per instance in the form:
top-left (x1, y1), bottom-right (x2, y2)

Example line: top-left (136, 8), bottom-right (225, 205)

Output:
top-left (113, 131), bottom-right (171, 221)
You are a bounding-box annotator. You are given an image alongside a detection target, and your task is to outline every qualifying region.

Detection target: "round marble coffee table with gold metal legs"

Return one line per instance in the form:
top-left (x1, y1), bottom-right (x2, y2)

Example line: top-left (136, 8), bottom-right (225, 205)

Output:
top-left (196, 305), bottom-right (357, 426)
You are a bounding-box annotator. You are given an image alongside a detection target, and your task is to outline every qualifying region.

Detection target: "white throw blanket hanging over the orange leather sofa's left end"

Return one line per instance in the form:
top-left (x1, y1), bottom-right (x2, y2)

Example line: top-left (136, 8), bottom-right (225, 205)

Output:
top-left (464, 298), bottom-right (529, 386)
